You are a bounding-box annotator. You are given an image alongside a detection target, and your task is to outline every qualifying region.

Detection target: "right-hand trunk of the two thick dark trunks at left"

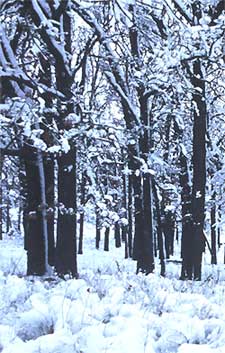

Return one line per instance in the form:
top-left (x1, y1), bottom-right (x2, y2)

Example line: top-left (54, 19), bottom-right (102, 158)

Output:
top-left (55, 7), bottom-right (78, 277)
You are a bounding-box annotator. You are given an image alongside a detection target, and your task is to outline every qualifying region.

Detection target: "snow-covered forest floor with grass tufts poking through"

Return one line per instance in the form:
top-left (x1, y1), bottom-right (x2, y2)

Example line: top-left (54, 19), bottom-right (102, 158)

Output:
top-left (0, 226), bottom-right (225, 353)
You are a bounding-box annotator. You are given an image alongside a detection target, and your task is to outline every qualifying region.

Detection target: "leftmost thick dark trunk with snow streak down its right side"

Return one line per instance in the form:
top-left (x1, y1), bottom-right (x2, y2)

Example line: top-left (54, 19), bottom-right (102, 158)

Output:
top-left (23, 141), bottom-right (52, 276)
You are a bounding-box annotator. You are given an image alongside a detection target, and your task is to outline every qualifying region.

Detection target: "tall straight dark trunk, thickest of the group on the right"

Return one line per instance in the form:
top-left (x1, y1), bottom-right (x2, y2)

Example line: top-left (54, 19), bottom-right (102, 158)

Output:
top-left (192, 59), bottom-right (207, 280)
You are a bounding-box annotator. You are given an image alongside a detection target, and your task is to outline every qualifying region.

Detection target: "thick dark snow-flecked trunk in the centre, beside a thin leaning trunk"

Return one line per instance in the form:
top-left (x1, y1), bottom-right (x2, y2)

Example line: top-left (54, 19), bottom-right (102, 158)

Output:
top-left (126, 5), bottom-right (154, 274)
